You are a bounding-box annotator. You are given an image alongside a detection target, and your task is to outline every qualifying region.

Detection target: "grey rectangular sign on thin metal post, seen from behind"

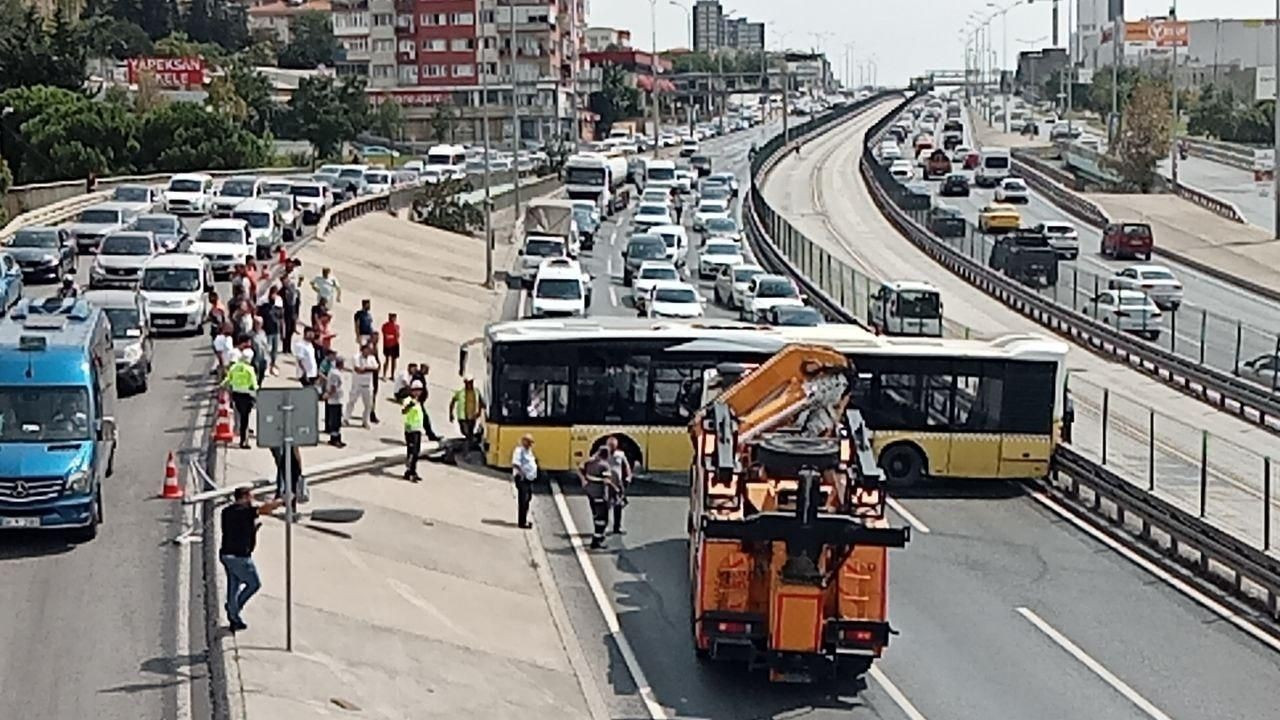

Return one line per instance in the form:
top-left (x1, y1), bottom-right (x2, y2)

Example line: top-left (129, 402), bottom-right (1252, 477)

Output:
top-left (257, 387), bottom-right (320, 652)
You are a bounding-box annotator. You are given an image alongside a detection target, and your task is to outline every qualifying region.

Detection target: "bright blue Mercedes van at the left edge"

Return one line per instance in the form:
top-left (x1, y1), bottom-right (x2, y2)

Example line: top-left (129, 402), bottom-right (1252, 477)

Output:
top-left (0, 299), bottom-right (116, 541)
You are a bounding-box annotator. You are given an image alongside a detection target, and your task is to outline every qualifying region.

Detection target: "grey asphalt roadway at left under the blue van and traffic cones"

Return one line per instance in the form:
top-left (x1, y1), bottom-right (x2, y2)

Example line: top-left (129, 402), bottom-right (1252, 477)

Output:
top-left (0, 202), bottom-right (313, 720)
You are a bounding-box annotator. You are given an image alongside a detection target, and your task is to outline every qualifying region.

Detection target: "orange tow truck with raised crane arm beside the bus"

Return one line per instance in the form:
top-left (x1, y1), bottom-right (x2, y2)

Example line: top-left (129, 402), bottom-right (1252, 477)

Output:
top-left (689, 345), bottom-right (910, 682)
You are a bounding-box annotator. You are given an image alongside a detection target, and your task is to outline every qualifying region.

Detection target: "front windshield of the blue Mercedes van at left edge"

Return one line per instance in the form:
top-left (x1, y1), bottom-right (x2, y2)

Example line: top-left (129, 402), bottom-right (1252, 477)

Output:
top-left (0, 386), bottom-right (90, 442)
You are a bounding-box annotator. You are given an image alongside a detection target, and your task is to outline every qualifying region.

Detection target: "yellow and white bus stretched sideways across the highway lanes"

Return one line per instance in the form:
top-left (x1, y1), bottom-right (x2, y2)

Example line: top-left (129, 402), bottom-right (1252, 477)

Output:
top-left (484, 316), bottom-right (1066, 484)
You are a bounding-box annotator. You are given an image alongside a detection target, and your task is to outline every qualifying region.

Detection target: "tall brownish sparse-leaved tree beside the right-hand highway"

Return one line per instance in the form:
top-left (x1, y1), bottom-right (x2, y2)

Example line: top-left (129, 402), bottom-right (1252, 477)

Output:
top-left (1105, 78), bottom-right (1171, 192)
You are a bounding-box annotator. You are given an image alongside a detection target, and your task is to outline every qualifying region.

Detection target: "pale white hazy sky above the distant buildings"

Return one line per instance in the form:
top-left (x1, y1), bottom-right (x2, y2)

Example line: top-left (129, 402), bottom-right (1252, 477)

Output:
top-left (588, 0), bottom-right (1276, 85)
